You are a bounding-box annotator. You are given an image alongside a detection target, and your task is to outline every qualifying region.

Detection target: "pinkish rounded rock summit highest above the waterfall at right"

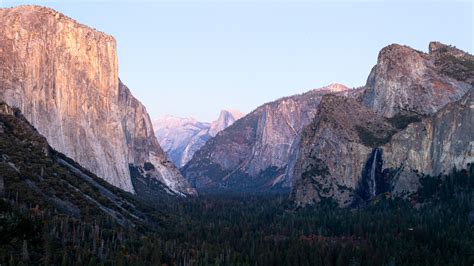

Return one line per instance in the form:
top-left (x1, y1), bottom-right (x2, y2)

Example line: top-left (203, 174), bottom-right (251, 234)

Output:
top-left (362, 43), bottom-right (471, 117)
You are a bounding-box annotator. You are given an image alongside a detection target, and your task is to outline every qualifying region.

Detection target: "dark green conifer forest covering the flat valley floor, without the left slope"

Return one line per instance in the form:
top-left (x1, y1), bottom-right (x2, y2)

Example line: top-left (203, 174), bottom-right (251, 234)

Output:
top-left (0, 166), bottom-right (474, 265)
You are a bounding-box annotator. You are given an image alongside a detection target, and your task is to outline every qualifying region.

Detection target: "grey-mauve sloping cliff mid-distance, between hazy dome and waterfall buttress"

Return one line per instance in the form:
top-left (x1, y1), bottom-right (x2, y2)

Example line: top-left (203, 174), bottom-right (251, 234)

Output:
top-left (182, 84), bottom-right (348, 191)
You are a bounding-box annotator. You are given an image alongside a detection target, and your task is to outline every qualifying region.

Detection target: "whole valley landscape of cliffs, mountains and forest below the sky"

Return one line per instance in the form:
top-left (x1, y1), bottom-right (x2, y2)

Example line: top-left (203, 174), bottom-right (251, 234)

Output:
top-left (0, 6), bottom-right (474, 265)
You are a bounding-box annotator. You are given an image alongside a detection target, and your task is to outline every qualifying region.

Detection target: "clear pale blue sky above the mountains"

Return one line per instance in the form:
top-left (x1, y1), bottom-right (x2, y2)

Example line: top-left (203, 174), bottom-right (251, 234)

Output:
top-left (0, 0), bottom-right (474, 121)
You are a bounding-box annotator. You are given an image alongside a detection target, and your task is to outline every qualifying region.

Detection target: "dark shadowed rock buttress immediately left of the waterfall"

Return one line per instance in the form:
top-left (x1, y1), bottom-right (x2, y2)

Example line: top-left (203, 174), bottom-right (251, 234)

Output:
top-left (292, 95), bottom-right (396, 206)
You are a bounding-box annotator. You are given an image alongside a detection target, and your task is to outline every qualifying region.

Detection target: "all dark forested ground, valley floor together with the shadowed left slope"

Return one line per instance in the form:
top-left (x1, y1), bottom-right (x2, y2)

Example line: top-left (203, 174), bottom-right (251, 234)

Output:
top-left (0, 103), bottom-right (474, 265)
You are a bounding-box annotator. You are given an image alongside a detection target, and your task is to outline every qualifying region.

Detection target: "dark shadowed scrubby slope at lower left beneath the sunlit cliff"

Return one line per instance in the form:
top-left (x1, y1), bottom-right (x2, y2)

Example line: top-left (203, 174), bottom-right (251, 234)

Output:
top-left (0, 102), bottom-right (156, 229)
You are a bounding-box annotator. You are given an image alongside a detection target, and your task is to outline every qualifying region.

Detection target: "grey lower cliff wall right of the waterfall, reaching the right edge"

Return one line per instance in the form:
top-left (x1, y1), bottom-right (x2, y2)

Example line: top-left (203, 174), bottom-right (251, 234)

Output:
top-left (381, 89), bottom-right (474, 194)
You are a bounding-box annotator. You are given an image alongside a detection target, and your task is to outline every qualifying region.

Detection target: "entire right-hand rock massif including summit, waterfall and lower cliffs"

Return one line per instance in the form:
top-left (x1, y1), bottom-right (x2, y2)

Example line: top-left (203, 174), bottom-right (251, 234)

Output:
top-left (291, 43), bottom-right (474, 207)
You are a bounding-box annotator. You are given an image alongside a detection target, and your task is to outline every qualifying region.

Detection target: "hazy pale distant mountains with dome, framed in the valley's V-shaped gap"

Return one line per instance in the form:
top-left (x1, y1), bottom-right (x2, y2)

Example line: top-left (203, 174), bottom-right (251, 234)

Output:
top-left (153, 110), bottom-right (244, 167)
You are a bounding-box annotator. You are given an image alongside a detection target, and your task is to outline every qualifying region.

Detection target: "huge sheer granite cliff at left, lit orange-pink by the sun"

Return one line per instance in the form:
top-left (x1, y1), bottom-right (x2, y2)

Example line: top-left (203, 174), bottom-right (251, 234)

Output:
top-left (0, 6), bottom-right (194, 193)
